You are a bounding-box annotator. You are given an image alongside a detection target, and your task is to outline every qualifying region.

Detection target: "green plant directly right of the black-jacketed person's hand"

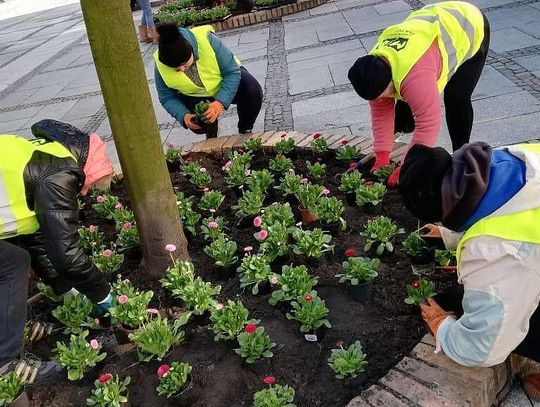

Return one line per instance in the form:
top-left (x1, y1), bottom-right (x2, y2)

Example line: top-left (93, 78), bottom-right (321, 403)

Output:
top-left (109, 291), bottom-right (154, 328)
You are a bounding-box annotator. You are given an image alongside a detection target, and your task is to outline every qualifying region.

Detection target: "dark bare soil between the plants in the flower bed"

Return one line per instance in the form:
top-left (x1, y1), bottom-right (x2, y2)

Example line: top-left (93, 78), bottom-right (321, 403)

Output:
top-left (30, 153), bottom-right (461, 407)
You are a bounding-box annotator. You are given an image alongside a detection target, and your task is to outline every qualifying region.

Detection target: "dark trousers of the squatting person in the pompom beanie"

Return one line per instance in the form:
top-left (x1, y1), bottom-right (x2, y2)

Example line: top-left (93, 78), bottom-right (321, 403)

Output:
top-left (179, 67), bottom-right (263, 138)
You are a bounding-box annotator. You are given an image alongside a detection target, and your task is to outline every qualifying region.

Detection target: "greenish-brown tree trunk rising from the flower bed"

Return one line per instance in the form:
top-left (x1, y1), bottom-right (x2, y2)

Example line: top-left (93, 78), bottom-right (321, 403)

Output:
top-left (81, 0), bottom-right (189, 277)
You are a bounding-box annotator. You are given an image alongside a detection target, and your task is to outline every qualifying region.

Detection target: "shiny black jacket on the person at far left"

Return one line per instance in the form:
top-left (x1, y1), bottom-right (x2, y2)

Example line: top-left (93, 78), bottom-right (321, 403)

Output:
top-left (9, 120), bottom-right (109, 302)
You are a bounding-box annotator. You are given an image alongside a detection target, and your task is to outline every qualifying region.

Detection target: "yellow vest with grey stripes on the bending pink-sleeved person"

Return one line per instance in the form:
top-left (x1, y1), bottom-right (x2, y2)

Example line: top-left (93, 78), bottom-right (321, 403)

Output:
top-left (369, 1), bottom-right (484, 99)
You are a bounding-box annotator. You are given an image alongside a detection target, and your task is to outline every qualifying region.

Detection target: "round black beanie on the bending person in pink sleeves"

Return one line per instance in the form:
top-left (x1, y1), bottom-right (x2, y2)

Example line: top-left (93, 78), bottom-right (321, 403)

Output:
top-left (349, 55), bottom-right (392, 100)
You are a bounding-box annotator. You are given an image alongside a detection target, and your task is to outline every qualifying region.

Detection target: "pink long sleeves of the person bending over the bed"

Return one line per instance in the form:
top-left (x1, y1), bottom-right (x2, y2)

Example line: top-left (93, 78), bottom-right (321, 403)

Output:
top-left (369, 40), bottom-right (442, 152)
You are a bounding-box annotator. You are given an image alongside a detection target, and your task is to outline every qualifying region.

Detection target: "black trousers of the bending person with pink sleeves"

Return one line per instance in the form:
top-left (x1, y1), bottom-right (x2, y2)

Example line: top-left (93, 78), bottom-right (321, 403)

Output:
top-left (394, 16), bottom-right (490, 151)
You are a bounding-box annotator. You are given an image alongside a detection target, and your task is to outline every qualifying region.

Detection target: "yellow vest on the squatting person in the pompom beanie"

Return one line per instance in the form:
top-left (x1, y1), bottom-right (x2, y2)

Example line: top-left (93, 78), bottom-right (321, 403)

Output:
top-left (154, 25), bottom-right (240, 97)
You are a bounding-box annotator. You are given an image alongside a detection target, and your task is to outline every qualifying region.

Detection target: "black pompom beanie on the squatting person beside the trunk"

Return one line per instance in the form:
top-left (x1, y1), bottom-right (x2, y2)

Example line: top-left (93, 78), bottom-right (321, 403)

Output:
top-left (156, 23), bottom-right (193, 68)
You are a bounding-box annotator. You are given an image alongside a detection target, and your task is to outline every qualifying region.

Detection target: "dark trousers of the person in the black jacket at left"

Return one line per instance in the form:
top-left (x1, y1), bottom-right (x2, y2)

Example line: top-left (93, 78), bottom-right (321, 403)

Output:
top-left (0, 240), bottom-right (30, 366)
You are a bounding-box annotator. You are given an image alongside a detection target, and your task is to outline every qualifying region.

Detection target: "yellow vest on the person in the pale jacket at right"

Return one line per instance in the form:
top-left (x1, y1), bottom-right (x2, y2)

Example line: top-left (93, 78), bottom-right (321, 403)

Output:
top-left (456, 144), bottom-right (540, 270)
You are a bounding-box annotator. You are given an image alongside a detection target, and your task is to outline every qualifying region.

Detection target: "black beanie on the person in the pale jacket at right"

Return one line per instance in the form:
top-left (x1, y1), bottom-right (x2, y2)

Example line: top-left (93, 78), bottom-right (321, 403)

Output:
top-left (398, 144), bottom-right (452, 222)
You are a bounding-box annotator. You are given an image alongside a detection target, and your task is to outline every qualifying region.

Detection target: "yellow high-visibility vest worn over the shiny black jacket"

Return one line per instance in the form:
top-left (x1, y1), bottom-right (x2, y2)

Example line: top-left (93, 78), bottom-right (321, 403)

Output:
top-left (0, 135), bottom-right (75, 239)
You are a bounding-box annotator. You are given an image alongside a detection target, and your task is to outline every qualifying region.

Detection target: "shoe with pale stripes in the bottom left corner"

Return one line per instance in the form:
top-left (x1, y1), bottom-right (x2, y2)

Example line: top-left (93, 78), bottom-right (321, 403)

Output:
top-left (0, 359), bottom-right (63, 386)
